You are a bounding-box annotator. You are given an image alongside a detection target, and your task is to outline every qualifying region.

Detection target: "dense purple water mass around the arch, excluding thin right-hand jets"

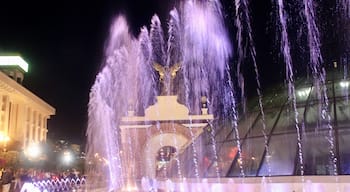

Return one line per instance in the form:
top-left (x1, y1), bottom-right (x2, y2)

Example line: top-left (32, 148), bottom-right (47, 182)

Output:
top-left (87, 1), bottom-right (238, 191)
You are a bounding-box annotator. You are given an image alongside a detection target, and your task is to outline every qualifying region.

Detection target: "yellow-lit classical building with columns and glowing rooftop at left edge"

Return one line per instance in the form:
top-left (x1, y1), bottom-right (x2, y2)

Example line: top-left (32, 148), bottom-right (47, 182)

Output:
top-left (0, 57), bottom-right (55, 149)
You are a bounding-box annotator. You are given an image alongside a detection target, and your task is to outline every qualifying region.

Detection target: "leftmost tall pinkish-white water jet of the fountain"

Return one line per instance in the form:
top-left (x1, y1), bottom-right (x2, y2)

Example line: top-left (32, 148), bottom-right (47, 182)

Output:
top-left (87, 17), bottom-right (138, 189)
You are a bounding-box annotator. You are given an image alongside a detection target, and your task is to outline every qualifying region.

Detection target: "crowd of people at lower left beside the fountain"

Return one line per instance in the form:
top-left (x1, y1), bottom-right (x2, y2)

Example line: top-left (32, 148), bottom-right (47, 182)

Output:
top-left (0, 168), bottom-right (82, 192)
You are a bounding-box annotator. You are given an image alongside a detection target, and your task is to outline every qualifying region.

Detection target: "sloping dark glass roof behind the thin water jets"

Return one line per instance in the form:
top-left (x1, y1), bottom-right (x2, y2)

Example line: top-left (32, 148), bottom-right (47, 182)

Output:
top-left (169, 73), bottom-right (350, 177)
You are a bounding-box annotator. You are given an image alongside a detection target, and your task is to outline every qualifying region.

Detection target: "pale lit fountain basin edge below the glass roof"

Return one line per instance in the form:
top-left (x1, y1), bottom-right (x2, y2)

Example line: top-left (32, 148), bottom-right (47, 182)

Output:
top-left (148, 176), bottom-right (350, 192)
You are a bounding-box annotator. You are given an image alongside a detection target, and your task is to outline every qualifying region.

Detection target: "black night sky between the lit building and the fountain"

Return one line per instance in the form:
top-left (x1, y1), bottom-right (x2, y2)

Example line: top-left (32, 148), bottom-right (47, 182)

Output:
top-left (0, 0), bottom-right (282, 143)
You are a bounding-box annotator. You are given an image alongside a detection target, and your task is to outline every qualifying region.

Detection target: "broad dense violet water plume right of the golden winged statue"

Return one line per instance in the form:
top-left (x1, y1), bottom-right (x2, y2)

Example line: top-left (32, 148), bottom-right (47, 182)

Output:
top-left (183, 1), bottom-right (232, 179)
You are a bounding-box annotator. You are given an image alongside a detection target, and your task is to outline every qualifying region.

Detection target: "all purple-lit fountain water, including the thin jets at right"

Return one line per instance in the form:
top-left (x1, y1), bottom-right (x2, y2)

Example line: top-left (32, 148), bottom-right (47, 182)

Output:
top-left (87, 0), bottom-right (342, 191)
